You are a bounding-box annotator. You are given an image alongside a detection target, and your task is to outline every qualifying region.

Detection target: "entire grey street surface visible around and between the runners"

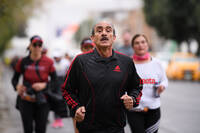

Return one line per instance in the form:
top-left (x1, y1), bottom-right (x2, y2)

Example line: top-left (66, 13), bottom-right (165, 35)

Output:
top-left (0, 68), bottom-right (200, 133)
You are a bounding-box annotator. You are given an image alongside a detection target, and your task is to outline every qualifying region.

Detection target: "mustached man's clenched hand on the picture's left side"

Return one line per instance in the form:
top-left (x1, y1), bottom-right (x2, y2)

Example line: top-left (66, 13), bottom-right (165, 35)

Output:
top-left (74, 106), bottom-right (86, 122)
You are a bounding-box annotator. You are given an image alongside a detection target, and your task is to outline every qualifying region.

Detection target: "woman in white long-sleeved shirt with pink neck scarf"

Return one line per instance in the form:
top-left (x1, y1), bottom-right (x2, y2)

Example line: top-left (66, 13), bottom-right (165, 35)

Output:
top-left (127, 34), bottom-right (168, 133)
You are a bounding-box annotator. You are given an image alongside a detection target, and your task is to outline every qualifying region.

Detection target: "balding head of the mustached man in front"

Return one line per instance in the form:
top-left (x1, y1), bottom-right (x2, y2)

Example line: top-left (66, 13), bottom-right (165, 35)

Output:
top-left (91, 22), bottom-right (116, 48)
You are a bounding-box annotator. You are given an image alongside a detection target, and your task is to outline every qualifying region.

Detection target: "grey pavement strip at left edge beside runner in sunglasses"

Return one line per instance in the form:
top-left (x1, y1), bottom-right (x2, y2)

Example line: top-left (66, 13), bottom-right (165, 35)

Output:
top-left (0, 64), bottom-right (22, 133)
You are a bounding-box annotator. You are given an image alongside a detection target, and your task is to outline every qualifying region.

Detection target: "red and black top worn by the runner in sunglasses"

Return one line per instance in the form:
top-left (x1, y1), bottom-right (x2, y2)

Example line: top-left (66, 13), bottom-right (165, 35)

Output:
top-left (12, 55), bottom-right (57, 95)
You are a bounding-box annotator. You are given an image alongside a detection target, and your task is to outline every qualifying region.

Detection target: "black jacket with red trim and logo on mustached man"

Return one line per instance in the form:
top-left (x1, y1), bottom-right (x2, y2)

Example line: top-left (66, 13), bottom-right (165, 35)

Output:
top-left (63, 49), bottom-right (142, 130)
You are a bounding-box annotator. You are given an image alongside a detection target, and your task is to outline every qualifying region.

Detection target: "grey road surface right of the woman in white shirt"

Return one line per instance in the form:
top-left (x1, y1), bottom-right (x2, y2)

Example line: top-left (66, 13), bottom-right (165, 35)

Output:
top-left (160, 81), bottom-right (200, 133)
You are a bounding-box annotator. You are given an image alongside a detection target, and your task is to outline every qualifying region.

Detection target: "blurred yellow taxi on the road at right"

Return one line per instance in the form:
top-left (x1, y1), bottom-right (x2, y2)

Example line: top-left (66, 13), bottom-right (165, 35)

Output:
top-left (166, 53), bottom-right (200, 80)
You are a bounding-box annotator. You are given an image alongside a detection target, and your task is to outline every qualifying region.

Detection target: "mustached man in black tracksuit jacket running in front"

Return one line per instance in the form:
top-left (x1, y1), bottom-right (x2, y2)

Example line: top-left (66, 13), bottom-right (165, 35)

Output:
top-left (62, 22), bottom-right (142, 133)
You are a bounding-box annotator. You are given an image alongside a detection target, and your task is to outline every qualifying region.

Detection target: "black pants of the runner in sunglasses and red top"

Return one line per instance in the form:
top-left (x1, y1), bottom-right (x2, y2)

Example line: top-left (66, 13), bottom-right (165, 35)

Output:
top-left (19, 100), bottom-right (49, 133)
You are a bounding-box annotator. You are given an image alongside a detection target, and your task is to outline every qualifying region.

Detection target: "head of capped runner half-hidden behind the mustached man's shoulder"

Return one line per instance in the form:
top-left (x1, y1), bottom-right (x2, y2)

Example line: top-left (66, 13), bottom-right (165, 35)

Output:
top-left (81, 37), bottom-right (95, 52)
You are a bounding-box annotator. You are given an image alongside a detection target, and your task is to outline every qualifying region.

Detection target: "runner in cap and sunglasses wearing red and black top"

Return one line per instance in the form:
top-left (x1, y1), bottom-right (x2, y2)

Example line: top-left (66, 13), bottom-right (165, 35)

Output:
top-left (12, 36), bottom-right (57, 133)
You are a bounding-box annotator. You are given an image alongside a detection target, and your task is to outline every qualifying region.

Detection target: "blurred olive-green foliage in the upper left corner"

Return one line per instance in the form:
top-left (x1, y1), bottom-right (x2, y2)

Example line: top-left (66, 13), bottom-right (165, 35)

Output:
top-left (0, 0), bottom-right (33, 55)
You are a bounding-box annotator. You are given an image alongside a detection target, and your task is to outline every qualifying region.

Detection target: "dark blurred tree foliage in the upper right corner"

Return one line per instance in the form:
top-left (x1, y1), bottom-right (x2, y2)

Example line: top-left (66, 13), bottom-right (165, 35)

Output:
top-left (144, 0), bottom-right (200, 54)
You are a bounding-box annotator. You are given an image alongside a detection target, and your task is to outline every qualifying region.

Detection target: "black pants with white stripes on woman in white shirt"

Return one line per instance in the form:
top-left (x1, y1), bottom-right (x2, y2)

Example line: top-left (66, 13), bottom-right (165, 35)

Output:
top-left (127, 108), bottom-right (161, 133)
